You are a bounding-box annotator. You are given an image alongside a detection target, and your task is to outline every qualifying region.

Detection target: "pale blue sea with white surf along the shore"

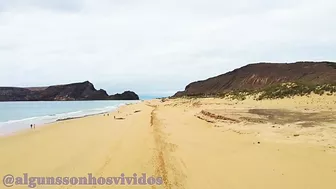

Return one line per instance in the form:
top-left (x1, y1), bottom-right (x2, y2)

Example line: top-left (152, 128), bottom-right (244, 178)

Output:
top-left (0, 100), bottom-right (139, 136)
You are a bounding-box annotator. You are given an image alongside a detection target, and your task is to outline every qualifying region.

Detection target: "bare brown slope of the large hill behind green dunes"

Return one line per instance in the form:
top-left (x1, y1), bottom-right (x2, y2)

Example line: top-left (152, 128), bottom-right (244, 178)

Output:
top-left (174, 62), bottom-right (336, 97)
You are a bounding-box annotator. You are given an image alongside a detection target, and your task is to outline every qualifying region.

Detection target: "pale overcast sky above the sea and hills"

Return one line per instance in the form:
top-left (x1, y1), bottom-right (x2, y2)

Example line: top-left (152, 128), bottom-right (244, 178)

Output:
top-left (0, 0), bottom-right (336, 96)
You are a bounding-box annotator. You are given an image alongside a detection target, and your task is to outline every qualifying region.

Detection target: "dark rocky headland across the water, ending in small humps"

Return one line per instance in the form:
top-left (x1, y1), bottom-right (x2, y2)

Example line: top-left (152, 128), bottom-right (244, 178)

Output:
top-left (0, 81), bottom-right (139, 101)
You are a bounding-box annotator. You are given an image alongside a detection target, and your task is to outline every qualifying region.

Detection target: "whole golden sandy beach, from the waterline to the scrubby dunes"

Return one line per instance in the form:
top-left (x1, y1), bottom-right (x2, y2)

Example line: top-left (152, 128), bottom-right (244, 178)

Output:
top-left (0, 95), bottom-right (336, 189)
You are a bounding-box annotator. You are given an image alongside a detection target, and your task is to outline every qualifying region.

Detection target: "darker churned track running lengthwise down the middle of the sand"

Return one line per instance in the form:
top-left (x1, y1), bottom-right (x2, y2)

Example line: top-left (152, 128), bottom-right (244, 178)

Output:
top-left (150, 106), bottom-right (185, 189)
